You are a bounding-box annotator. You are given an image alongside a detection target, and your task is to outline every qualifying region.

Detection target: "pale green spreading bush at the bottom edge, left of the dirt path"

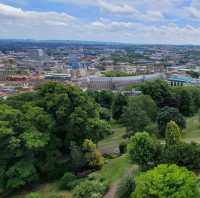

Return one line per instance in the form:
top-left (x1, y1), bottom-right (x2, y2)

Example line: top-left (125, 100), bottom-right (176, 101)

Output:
top-left (73, 180), bottom-right (107, 198)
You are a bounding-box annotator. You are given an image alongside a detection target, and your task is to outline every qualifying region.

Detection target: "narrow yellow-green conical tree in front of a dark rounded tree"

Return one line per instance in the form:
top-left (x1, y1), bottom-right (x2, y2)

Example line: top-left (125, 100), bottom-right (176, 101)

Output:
top-left (165, 121), bottom-right (181, 146)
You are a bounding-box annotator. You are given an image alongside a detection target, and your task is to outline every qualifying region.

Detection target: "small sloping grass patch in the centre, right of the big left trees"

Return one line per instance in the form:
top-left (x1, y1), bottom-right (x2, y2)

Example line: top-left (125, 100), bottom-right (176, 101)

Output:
top-left (98, 124), bottom-right (126, 153)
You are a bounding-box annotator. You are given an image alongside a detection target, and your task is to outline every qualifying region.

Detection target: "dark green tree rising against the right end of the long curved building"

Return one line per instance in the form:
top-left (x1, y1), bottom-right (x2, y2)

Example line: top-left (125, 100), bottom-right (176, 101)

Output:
top-left (141, 80), bottom-right (176, 107)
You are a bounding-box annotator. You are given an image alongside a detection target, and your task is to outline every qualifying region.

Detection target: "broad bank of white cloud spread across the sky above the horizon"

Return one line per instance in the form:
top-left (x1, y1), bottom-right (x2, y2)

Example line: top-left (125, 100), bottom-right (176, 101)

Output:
top-left (0, 0), bottom-right (200, 44)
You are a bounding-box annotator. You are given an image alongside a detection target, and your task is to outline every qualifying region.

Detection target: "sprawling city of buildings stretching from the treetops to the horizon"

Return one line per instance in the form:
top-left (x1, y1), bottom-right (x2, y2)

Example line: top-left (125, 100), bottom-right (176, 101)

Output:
top-left (0, 40), bottom-right (200, 97)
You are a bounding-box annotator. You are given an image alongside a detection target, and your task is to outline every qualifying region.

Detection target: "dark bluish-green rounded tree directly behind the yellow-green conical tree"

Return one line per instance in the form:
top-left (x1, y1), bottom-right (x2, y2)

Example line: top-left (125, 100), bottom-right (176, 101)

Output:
top-left (157, 107), bottom-right (186, 137)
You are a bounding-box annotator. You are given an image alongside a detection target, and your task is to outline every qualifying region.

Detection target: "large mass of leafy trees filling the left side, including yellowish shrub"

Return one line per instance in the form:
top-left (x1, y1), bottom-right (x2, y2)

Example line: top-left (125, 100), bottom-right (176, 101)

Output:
top-left (0, 82), bottom-right (111, 191)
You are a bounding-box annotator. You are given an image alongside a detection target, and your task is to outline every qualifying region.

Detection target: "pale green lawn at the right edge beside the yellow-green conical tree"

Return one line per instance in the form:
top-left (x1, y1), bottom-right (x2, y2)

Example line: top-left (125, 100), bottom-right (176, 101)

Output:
top-left (183, 116), bottom-right (200, 143)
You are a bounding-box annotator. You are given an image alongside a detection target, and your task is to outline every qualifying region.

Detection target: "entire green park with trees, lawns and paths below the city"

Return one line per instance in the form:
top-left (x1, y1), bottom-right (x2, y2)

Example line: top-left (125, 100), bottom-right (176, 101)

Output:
top-left (0, 80), bottom-right (200, 198)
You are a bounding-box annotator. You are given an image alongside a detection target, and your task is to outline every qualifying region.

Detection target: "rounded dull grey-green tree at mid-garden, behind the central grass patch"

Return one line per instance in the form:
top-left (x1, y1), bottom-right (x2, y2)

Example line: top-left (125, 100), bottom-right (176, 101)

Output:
top-left (121, 101), bottom-right (150, 133)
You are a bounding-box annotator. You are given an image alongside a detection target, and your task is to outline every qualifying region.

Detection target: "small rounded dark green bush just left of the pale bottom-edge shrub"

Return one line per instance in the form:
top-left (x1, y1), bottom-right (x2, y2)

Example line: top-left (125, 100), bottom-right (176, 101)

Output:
top-left (60, 172), bottom-right (77, 190)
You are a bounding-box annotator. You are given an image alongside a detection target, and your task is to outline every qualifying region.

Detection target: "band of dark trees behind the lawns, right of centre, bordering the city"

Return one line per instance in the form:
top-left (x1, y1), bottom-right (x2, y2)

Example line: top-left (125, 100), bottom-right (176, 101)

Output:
top-left (89, 80), bottom-right (200, 137)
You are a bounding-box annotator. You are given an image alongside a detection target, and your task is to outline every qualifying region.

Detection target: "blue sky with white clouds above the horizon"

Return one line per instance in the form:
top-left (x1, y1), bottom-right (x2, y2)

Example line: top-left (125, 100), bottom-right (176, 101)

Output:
top-left (0, 0), bottom-right (200, 44)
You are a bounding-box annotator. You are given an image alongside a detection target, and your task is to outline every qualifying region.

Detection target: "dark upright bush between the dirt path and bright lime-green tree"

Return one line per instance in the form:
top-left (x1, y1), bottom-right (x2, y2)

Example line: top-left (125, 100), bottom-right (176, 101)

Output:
top-left (116, 174), bottom-right (135, 198)
